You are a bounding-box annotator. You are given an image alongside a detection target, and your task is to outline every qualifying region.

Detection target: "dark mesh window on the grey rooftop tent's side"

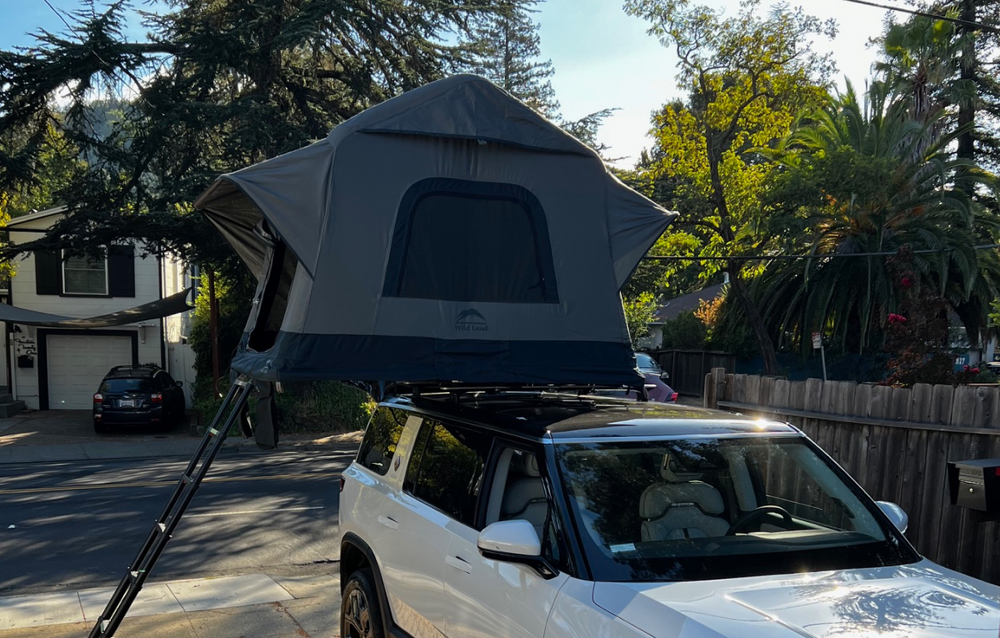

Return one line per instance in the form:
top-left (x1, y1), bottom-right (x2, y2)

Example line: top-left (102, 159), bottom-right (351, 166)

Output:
top-left (383, 179), bottom-right (559, 303)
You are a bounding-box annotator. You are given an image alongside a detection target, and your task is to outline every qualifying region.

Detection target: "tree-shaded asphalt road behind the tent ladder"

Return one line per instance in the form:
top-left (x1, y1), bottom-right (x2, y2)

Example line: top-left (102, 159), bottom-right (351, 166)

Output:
top-left (0, 451), bottom-right (353, 595)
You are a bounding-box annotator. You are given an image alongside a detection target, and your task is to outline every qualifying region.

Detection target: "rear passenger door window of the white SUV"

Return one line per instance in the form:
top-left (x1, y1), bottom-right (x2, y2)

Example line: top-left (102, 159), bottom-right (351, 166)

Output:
top-left (403, 419), bottom-right (490, 527)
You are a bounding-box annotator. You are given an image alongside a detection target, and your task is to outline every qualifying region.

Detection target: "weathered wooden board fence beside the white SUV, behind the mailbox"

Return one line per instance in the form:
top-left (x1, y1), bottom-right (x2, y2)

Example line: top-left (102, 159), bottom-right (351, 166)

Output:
top-left (704, 368), bottom-right (1000, 584)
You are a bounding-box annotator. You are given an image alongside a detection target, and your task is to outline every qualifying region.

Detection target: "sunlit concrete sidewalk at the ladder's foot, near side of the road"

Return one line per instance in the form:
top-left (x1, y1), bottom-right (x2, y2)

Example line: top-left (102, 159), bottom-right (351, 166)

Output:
top-left (0, 574), bottom-right (340, 638)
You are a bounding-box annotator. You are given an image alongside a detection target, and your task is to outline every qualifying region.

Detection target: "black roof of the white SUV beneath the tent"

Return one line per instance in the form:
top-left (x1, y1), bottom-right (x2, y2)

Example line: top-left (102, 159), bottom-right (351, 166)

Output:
top-left (386, 393), bottom-right (798, 440)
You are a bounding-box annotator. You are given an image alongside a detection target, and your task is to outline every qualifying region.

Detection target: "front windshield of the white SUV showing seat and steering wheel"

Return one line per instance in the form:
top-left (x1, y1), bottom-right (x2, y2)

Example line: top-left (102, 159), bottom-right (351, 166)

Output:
top-left (556, 436), bottom-right (918, 581)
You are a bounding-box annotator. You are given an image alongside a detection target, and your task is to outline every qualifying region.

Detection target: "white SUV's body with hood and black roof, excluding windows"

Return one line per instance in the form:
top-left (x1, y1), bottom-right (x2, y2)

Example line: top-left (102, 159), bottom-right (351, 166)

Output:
top-left (341, 396), bottom-right (1000, 638)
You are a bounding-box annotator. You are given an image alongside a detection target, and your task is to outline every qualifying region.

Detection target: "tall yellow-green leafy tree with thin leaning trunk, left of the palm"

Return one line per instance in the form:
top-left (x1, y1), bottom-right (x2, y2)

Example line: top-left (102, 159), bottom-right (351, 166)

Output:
top-left (625, 0), bottom-right (835, 374)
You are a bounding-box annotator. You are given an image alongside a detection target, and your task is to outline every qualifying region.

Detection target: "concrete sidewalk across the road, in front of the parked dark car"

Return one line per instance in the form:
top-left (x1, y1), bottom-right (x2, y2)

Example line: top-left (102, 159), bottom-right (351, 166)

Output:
top-left (0, 410), bottom-right (361, 464)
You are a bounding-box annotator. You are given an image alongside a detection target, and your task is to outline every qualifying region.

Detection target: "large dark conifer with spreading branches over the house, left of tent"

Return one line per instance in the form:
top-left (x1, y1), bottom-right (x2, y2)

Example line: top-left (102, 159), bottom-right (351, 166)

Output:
top-left (0, 0), bottom-right (516, 276)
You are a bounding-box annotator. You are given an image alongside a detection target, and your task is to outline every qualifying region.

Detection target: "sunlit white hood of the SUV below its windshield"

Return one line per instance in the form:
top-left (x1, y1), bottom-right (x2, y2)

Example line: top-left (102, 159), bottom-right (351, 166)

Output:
top-left (594, 561), bottom-right (1000, 638)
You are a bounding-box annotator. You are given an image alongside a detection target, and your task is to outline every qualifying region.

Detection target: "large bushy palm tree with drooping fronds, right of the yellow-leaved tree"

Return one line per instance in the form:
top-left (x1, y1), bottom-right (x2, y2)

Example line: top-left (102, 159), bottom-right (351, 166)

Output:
top-left (754, 82), bottom-right (1000, 352)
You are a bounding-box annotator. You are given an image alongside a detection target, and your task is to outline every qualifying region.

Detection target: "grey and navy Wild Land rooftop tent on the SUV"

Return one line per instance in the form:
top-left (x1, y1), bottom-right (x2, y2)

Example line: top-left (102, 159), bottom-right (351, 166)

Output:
top-left (195, 75), bottom-right (674, 385)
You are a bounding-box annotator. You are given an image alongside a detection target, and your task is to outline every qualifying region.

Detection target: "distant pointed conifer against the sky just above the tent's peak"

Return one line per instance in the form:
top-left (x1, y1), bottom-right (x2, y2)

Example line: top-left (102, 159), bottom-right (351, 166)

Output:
top-left (463, 0), bottom-right (559, 120)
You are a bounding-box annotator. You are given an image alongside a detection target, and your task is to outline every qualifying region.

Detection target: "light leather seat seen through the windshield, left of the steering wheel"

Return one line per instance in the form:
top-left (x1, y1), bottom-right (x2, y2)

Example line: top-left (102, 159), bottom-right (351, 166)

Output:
top-left (639, 456), bottom-right (729, 541)
